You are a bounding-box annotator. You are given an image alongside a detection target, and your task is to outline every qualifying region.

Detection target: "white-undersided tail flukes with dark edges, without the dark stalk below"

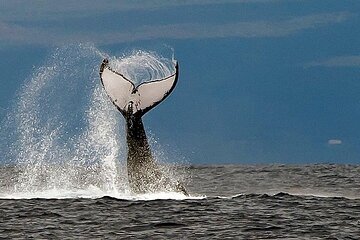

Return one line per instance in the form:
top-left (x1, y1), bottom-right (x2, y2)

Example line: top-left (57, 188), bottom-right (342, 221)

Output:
top-left (100, 59), bottom-right (179, 116)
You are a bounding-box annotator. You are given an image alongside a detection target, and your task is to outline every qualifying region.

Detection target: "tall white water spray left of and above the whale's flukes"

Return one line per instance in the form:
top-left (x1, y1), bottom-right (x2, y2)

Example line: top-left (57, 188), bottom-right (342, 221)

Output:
top-left (0, 44), bottom-right (188, 200)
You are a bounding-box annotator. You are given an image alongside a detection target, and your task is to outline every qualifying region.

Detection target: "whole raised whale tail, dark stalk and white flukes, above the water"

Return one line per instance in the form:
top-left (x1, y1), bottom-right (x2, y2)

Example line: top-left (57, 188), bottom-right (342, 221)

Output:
top-left (99, 59), bottom-right (188, 195)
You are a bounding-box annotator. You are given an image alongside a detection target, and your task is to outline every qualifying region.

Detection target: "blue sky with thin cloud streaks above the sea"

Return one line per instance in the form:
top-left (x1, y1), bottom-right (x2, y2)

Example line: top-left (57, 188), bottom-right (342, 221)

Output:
top-left (0, 0), bottom-right (360, 164)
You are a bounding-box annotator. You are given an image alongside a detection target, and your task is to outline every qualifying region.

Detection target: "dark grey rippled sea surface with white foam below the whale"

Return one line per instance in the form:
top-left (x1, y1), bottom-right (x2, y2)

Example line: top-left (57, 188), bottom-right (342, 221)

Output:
top-left (0, 164), bottom-right (360, 239)
